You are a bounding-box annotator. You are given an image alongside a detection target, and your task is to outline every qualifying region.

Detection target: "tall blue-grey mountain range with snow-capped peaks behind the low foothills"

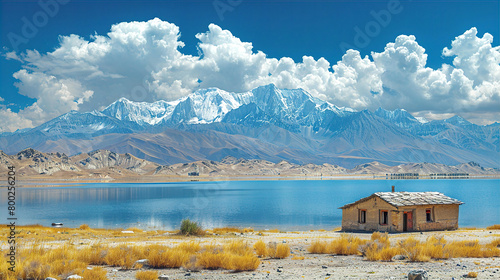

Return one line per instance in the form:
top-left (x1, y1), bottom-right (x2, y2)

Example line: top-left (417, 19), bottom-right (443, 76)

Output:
top-left (0, 84), bottom-right (500, 167)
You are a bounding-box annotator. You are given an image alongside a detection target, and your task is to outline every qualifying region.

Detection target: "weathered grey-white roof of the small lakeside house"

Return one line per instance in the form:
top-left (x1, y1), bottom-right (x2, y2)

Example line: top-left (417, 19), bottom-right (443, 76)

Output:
top-left (339, 192), bottom-right (464, 209)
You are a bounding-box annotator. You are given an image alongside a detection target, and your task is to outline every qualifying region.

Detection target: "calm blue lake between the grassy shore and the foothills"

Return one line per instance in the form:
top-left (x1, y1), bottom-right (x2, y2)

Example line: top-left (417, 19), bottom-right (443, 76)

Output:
top-left (0, 179), bottom-right (500, 230)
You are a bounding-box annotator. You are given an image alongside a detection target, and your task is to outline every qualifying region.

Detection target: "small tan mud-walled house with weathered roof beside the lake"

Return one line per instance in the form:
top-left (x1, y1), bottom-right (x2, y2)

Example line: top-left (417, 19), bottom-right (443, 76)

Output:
top-left (339, 187), bottom-right (463, 232)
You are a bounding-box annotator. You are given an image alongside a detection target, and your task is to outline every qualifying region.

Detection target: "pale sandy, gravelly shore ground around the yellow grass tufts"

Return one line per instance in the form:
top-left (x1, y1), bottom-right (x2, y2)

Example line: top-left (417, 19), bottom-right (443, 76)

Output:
top-left (2, 229), bottom-right (500, 280)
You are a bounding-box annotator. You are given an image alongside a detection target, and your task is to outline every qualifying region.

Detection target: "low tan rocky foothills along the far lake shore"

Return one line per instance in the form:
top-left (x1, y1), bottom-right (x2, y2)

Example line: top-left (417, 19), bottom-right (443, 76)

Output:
top-left (0, 148), bottom-right (500, 179)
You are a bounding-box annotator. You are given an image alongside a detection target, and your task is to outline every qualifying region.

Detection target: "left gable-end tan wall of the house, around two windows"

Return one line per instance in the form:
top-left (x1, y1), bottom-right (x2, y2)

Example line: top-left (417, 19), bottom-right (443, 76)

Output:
top-left (342, 197), bottom-right (397, 231)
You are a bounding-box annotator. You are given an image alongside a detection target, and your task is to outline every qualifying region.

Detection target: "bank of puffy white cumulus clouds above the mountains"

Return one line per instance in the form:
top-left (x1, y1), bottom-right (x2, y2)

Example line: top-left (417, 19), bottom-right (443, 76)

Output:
top-left (0, 18), bottom-right (500, 131)
